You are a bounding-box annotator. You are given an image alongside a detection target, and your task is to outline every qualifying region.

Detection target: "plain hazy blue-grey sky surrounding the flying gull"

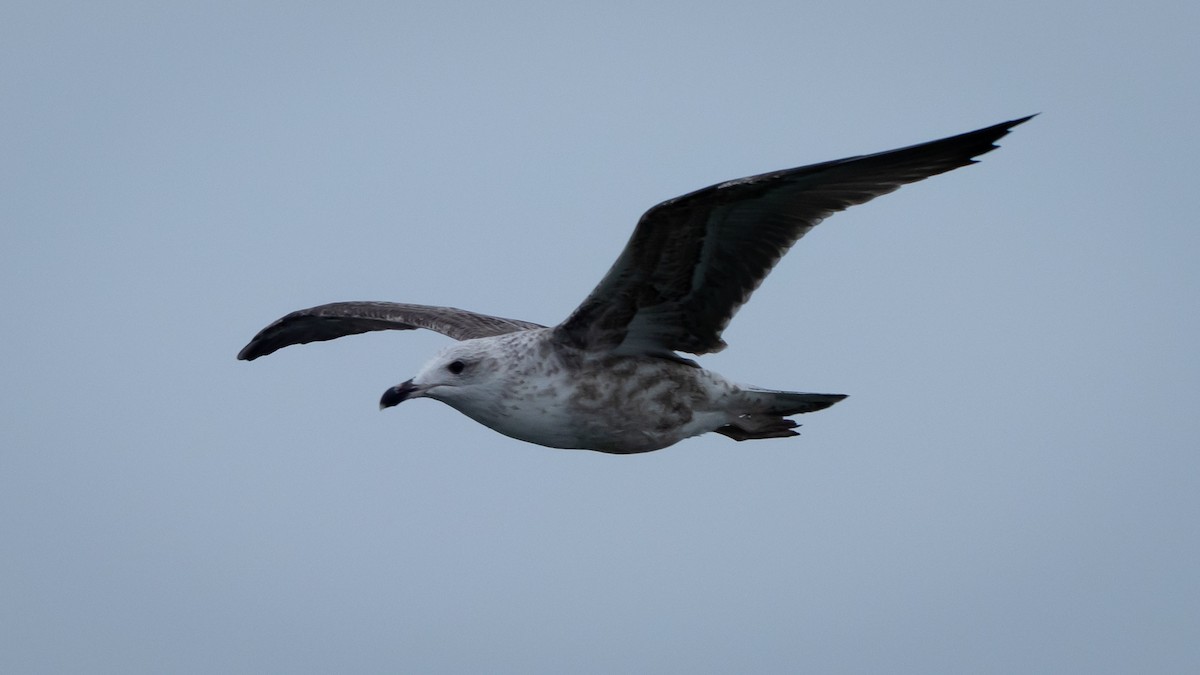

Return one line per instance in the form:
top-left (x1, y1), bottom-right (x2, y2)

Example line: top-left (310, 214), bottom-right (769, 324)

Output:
top-left (0, 0), bottom-right (1200, 674)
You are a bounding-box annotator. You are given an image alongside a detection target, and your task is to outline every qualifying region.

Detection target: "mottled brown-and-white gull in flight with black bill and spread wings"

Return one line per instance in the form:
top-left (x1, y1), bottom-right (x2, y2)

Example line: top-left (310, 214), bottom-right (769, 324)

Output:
top-left (238, 115), bottom-right (1032, 454)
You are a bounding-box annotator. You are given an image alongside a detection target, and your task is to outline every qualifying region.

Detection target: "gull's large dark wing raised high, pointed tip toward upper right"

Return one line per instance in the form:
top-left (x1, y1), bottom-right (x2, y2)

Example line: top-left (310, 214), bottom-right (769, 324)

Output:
top-left (554, 115), bottom-right (1032, 356)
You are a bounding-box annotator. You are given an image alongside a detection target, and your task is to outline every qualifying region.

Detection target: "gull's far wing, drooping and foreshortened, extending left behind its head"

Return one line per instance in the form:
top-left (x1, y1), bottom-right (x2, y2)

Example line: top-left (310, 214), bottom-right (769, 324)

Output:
top-left (238, 303), bottom-right (545, 360)
